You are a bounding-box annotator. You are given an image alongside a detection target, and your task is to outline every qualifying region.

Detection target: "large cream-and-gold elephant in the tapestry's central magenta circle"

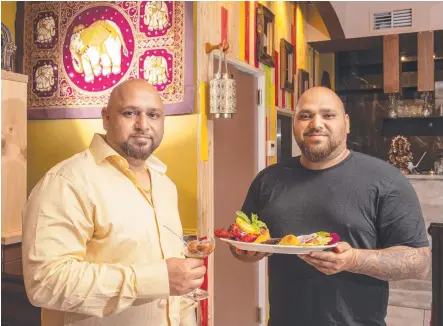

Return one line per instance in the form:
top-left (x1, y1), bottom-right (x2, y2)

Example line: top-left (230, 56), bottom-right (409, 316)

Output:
top-left (69, 20), bottom-right (129, 83)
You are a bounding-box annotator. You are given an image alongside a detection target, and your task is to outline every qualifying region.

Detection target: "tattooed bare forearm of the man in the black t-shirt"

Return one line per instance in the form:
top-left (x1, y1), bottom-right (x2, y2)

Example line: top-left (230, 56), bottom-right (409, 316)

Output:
top-left (349, 246), bottom-right (431, 281)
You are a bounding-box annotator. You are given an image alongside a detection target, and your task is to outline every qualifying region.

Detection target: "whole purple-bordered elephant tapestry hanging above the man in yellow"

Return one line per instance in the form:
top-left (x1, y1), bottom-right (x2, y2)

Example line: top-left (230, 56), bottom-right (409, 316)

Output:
top-left (24, 1), bottom-right (195, 119)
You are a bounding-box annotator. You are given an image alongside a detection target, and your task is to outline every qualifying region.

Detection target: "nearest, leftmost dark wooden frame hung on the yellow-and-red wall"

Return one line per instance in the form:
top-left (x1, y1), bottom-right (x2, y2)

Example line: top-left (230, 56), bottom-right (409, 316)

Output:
top-left (256, 4), bottom-right (275, 67)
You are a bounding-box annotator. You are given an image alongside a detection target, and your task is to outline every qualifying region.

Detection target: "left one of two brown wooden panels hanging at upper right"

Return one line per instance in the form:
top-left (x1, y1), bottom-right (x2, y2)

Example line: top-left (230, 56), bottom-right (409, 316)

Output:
top-left (383, 34), bottom-right (400, 93)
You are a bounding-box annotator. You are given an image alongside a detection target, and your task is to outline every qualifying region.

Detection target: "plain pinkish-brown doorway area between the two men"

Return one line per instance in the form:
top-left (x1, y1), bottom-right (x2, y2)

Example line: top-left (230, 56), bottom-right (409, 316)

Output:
top-left (213, 62), bottom-right (260, 326)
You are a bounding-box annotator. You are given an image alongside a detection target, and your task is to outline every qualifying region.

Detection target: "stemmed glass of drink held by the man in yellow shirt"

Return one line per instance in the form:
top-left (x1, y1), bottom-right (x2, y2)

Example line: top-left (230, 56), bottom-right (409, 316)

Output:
top-left (183, 235), bottom-right (215, 301)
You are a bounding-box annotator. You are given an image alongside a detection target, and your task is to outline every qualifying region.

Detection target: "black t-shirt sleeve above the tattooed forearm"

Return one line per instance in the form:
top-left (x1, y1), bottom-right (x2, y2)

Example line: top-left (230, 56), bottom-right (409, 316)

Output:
top-left (377, 175), bottom-right (429, 248)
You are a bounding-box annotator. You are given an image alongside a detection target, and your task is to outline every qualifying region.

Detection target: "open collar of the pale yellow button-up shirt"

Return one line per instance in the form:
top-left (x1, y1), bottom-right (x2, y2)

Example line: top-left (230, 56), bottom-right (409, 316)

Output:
top-left (89, 134), bottom-right (167, 174)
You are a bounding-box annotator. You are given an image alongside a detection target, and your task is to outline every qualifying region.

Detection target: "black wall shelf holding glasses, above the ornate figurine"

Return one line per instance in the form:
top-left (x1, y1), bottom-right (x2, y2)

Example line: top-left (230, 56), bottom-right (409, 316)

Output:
top-left (381, 117), bottom-right (443, 136)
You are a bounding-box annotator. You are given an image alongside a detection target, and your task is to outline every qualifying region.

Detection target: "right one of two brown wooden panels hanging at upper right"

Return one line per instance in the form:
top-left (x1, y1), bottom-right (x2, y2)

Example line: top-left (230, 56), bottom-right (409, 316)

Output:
top-left (417, 31), bottom-right (434, 92)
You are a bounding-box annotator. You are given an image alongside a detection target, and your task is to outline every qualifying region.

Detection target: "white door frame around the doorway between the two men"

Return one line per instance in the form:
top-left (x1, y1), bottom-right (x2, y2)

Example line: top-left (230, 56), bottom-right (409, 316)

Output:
top-left (208, 52), bottom-right (267, 326)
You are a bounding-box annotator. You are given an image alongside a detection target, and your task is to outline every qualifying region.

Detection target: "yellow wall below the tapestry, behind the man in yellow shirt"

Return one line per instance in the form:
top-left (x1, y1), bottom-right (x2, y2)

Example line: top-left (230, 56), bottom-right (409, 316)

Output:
top-left (28, 114), bottom-right (197, 232)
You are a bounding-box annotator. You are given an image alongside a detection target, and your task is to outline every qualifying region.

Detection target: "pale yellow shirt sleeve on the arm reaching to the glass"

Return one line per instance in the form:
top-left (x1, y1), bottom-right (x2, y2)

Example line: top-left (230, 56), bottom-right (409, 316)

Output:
top-left (22, 174), bottom-right (169, 317)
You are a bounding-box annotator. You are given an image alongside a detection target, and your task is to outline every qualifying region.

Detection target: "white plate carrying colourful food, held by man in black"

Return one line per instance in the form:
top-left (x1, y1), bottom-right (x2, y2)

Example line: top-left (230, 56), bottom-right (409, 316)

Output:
top-left (220, 238), bottom-right (337, 255)
